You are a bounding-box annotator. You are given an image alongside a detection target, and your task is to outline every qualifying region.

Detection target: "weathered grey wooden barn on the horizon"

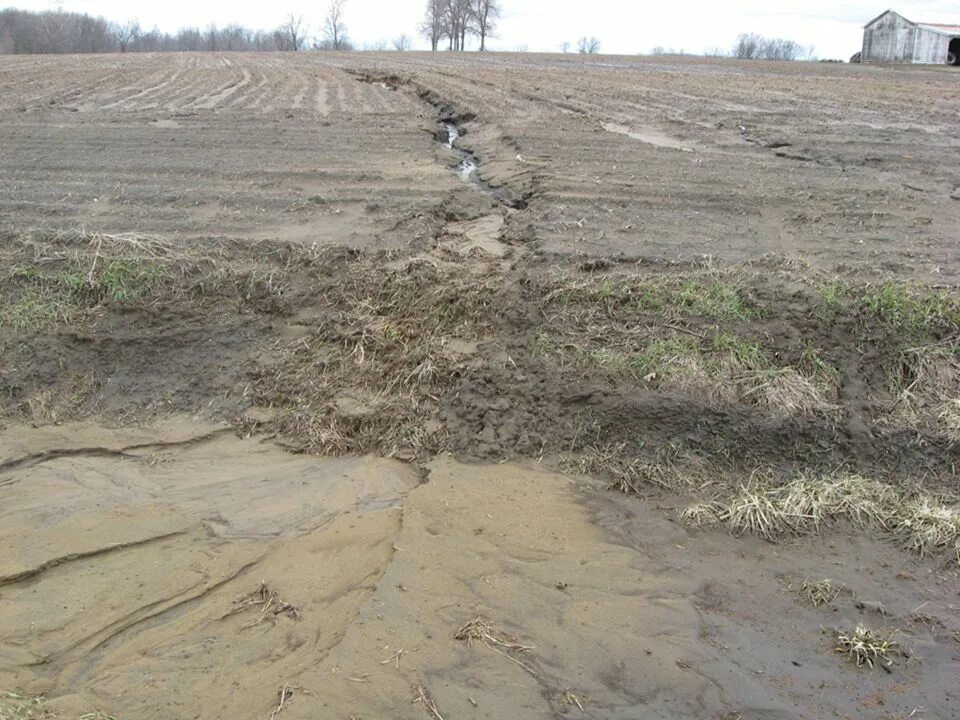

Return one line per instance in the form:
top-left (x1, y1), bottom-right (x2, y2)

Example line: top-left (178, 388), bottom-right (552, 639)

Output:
top-left (860, 10), bottom-right (960, 65)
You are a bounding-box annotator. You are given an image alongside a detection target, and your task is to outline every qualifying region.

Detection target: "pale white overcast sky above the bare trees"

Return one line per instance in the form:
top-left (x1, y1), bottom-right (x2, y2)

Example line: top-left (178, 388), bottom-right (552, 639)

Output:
top-left (7, 0), bottom-right (960, 59)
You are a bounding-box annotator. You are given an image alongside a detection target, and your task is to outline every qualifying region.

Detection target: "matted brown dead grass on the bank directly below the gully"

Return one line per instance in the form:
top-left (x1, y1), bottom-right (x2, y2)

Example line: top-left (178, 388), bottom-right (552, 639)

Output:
top-left (249, 259), bottom-right (502, 455)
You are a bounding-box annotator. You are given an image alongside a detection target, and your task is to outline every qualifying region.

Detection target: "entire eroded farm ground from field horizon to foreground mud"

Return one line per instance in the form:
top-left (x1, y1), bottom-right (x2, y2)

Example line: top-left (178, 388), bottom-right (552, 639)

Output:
top-left (0, 53), bottom-right (960, 720)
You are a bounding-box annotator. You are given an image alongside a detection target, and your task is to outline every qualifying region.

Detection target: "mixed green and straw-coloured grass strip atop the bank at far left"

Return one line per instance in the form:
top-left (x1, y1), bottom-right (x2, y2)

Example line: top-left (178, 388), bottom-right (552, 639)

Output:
top-left (0, 229), bottom-right (322, 332)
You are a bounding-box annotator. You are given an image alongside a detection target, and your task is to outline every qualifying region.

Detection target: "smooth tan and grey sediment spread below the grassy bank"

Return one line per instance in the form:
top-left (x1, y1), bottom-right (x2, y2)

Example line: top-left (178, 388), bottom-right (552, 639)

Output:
top-left (0, 419), bottom-right (960, 719)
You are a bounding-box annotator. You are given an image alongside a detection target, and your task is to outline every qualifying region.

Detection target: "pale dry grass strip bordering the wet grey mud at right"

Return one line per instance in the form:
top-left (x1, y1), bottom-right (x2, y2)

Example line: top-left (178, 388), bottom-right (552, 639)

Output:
top-left (680, 474), bottom-right (960, 564)
